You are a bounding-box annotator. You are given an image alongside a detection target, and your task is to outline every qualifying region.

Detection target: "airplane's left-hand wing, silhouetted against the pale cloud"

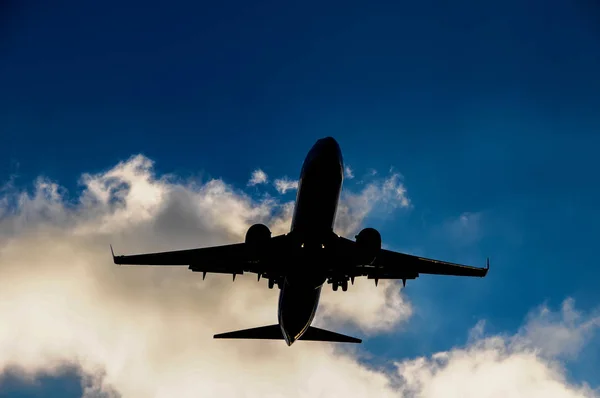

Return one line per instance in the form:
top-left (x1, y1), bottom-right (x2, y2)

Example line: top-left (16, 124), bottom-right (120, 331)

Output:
top-left (111, 235), bottom-right (286, 278)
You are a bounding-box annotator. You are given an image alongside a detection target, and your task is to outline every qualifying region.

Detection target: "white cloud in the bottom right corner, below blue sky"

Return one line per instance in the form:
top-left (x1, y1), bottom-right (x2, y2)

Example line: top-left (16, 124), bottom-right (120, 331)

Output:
top-left (396, 299), bottom-right (600, 398)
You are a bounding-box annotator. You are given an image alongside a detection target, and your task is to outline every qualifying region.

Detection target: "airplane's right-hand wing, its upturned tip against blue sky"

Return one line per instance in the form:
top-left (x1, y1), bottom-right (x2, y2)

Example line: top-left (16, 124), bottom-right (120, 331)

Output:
top-left (341, 238), bottom-right (490, 281)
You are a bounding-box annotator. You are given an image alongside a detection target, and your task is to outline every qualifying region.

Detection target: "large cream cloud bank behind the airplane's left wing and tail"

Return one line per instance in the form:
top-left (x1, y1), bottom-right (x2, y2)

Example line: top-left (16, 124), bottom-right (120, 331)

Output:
top-left (0, 156), bottom-right (409, 397)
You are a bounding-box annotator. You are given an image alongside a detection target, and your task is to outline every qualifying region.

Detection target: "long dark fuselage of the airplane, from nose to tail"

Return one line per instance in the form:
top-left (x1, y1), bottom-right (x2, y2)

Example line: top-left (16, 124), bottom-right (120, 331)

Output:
top-left (278, 137), bottom-right (344, 346)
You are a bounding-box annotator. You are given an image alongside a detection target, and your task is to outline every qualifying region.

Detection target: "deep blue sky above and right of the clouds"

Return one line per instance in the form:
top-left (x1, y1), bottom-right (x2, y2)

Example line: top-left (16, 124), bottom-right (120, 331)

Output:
top-left (0, 0), bottom-right (600, 397)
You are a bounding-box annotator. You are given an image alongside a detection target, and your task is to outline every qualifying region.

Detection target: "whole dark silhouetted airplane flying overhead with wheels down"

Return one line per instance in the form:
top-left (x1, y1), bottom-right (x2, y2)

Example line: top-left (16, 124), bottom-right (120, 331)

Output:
top-left (111, 137), bottom-right (489, 346)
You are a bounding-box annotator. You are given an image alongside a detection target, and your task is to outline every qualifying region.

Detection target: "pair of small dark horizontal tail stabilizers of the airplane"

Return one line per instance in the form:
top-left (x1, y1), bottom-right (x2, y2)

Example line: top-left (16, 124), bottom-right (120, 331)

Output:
top-left (214, 324), bottom-right (362, 343)
